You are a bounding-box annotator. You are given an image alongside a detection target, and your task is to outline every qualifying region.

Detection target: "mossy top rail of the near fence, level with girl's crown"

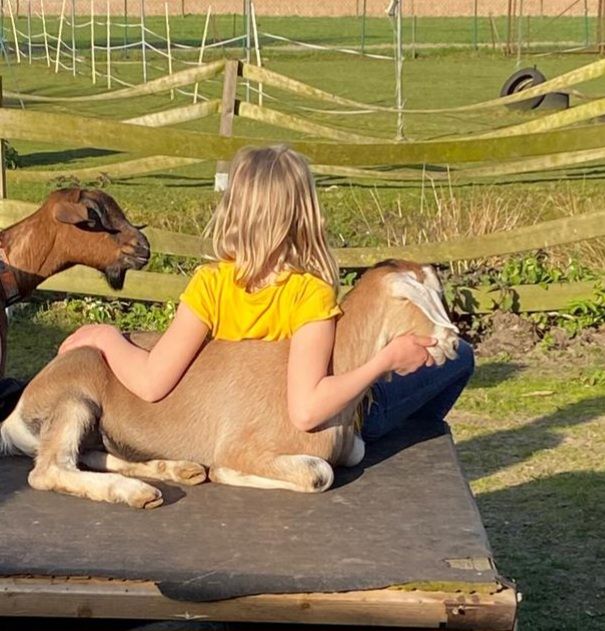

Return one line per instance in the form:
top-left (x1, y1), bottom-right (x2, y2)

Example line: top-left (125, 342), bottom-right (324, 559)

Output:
top-left (8, 108), bottom-right (605, 166)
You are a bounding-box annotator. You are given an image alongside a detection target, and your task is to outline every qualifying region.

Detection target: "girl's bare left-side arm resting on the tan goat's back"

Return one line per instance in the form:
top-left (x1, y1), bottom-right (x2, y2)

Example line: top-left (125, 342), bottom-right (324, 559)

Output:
top-left (59, 303), bottom-right (208, 401)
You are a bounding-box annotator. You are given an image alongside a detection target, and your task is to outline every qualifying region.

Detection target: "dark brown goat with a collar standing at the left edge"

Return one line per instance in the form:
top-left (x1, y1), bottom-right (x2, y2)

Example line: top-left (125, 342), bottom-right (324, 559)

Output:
top-left (0, 188), bottom-right (149, 376)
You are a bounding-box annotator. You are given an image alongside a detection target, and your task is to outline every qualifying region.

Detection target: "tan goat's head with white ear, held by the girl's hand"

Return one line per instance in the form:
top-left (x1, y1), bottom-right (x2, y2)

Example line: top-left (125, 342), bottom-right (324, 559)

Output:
top-left (343, 259), bottom-right (458, 365)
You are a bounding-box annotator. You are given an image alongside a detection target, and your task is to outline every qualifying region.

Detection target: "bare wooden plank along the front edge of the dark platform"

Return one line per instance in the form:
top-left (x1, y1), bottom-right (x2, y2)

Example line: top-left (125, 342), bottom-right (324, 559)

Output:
top-left (0, 578), bottom-right (517, 631)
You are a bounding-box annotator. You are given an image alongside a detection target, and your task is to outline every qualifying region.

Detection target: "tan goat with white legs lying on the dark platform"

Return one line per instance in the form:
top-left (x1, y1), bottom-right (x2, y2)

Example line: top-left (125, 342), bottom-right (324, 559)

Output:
top-left (0, 261), bottom-right (458, 508)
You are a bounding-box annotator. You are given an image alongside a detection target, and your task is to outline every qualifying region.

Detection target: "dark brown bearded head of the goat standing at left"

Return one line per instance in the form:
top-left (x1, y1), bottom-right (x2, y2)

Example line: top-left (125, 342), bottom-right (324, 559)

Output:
top-left (44, 188), bottom-right (150, 289)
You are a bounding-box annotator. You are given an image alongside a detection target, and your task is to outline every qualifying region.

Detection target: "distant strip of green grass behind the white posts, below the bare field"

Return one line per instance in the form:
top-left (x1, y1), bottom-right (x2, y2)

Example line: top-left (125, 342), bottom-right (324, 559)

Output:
top-left (4, 15), bottom-right (597, 50)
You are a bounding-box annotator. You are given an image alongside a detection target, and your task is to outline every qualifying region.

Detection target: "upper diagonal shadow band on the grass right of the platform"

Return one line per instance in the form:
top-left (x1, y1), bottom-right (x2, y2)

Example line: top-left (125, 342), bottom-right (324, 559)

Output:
top-left (456, 396), bottom-right (605, 484)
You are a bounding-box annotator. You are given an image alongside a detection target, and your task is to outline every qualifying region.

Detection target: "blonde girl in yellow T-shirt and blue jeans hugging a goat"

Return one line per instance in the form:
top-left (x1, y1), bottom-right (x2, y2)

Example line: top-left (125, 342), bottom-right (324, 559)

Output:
top-left (59, 146), bottom-right (473, 439)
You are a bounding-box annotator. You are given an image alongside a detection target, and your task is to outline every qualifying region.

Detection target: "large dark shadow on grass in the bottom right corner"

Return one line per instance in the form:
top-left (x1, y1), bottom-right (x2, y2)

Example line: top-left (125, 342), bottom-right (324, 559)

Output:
top-left (476, 472), bottom-right (605, 631)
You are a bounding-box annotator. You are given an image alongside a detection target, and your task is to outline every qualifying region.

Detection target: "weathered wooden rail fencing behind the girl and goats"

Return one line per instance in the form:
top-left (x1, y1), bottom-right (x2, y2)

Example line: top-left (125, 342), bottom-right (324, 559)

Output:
top-left (0, 61), bottom-right (605, 313)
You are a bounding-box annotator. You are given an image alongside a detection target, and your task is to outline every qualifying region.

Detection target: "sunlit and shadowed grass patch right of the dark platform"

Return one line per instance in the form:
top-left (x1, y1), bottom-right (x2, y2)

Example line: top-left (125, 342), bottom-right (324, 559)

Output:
top-left (450, 349), bottom-right (605, 631)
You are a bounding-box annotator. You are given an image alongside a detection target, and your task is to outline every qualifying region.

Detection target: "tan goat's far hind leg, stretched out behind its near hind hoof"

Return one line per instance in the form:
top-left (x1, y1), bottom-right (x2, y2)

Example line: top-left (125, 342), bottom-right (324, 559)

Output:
top-left (80, 451), bottom-right (206, 486)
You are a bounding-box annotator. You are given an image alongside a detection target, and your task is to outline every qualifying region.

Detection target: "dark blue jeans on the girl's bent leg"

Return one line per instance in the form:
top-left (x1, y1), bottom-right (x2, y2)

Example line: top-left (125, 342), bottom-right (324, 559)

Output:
top-left (361, 340), bottom-right (475, 442)
